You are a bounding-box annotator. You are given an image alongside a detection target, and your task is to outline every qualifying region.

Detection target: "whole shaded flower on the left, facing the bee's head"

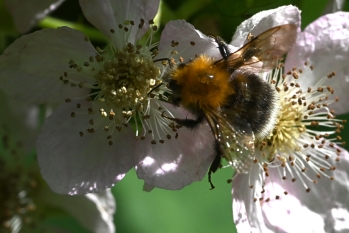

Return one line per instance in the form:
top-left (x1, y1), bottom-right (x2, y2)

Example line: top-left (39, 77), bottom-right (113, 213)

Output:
top-left (0, 0), bottom-right (214, 194)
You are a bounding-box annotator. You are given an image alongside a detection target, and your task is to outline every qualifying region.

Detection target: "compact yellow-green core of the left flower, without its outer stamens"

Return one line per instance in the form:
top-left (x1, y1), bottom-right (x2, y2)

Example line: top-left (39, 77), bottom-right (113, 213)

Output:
top-left (95, 43), bottom-right (160, 114)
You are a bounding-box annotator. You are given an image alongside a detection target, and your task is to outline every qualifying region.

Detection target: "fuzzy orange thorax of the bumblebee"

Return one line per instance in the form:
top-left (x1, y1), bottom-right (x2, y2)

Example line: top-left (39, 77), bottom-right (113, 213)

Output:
top-left (171, 55), bottom-right (233, 109)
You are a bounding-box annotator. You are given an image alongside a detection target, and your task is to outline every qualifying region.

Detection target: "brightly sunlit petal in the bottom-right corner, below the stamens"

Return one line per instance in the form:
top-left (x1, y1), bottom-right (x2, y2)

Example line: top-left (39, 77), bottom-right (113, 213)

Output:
top-left (233, 149), bottom-right (349, 233)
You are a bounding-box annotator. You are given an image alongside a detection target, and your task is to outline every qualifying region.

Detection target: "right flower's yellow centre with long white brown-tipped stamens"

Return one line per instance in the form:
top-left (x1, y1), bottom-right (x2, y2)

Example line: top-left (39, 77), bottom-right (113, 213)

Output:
top-left (250, 63), bottom-right (345, 201)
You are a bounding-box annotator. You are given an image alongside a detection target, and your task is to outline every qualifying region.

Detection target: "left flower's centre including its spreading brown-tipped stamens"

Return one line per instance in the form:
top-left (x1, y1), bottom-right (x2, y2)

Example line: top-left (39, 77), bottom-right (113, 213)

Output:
top-left (60, 20), bottom-right (176, 146)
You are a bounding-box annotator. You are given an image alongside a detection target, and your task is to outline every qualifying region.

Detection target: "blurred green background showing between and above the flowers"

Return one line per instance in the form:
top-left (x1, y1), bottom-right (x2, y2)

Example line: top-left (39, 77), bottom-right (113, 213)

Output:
top-left (0, 0), bottom-right (349, 233)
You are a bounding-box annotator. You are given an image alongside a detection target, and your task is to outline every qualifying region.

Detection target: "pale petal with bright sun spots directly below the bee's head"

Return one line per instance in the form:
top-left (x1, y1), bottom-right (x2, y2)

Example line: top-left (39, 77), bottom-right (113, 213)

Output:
top-left (136, 100), bottom-right (215, 190)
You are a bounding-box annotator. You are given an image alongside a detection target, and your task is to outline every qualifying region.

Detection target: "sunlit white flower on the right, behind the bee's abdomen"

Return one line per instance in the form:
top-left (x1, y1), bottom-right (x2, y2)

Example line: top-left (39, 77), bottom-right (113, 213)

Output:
top-left (233, 12), bottom-right (349, 232)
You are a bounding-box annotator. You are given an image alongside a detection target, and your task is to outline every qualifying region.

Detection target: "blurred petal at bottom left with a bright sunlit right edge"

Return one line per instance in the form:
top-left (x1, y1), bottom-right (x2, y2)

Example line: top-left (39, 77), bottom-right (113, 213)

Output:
top-left (41, 189), bottom-right (116, 233)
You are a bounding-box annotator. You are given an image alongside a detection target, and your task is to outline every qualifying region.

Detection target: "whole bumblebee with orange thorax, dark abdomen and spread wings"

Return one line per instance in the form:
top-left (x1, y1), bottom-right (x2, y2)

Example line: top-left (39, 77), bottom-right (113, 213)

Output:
top-left (163, 24), bottom-right (297, 189)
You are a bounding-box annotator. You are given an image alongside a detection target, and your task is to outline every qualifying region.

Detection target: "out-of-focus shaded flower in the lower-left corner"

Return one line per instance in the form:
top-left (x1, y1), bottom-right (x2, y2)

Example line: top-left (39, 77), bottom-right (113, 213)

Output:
top-left (0, 89), bottom-right (115, 233)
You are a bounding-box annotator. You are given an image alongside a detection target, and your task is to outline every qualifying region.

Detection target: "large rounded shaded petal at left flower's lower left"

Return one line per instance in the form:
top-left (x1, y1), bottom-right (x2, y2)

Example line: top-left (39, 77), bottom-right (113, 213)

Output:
top-left (37, 101), bottom-right (136, 194)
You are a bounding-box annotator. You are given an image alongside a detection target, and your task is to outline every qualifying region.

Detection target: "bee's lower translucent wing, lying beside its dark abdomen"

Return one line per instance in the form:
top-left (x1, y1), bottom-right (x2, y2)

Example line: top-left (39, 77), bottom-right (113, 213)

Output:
top-left (206, 110), bottom-right (254, 173)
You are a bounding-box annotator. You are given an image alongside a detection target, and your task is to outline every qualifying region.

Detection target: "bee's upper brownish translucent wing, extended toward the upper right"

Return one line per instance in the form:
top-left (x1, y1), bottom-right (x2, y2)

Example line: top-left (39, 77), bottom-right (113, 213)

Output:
top-left (215, 24), bottom-right (297, 72)
